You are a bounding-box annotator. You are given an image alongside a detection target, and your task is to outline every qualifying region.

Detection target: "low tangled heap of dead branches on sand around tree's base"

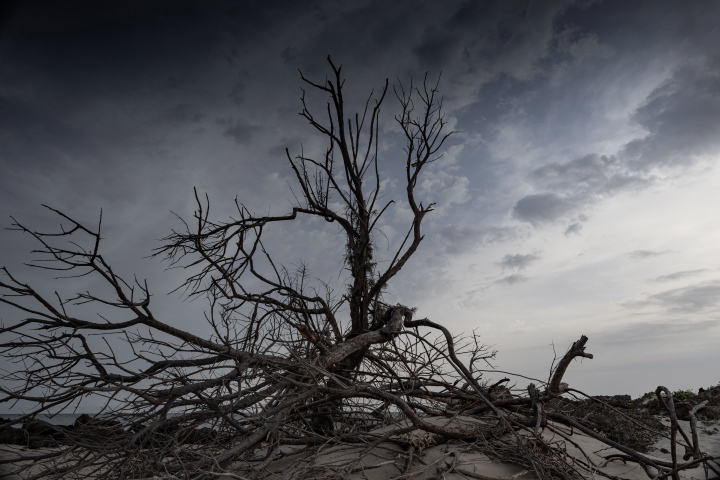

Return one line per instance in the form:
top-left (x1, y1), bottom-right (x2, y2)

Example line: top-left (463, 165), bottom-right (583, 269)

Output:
top-left (3, 330), bottom-right (720, 479)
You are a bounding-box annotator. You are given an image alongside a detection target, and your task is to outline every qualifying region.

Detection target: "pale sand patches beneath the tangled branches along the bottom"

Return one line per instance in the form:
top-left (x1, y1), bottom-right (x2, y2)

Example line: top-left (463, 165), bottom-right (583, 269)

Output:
top-left (0, 417), bottom-right (720, 480)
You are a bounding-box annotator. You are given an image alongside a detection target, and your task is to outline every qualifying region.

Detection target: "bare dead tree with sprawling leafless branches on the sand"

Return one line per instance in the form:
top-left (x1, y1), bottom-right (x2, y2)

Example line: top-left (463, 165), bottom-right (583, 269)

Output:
top-left (0, 59), bottom-right (718, 480)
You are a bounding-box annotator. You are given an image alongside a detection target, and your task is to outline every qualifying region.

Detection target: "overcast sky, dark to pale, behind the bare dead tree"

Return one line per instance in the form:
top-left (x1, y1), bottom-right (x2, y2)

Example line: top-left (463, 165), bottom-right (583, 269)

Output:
top-left (0, 0), bottom-right (720, 395)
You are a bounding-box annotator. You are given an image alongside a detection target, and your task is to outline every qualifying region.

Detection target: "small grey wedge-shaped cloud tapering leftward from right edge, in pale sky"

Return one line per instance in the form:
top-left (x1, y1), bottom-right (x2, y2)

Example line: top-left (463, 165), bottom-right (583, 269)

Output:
top-left (623, 281), bottom-right (720, 314)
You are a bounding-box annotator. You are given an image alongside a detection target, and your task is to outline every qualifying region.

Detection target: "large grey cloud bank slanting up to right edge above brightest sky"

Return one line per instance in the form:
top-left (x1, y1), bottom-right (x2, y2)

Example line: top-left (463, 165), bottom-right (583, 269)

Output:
top-left (513, 56), bottom-right (720, 225)
